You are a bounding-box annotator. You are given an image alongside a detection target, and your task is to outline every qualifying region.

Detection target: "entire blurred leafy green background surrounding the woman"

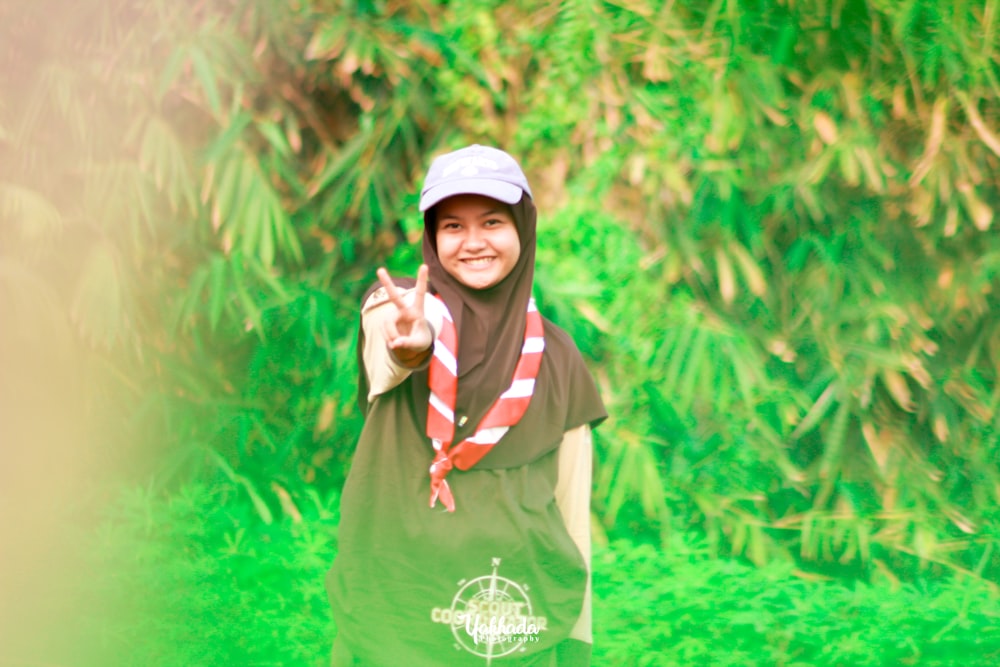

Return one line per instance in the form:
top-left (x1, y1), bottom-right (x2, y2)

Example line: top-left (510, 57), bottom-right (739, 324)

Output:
top-left (0, 0), bottom-right (1000, 667)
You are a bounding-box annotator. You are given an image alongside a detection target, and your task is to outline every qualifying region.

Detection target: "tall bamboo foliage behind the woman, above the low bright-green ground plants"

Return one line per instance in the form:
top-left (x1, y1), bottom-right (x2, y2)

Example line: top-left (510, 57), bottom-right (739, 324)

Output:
top-left (0, 0), bottom-right (1000, 580)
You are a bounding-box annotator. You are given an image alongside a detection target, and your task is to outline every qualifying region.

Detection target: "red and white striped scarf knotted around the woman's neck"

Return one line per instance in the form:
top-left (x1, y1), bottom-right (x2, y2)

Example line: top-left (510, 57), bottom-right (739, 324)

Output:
top-left (427, 297), bottom-right (545, 512)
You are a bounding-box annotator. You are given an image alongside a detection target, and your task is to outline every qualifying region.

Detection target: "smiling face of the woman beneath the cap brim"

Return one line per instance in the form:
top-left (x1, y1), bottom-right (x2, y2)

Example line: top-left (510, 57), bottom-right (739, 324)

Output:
top-left (435, 195), bottom-right (521, 289)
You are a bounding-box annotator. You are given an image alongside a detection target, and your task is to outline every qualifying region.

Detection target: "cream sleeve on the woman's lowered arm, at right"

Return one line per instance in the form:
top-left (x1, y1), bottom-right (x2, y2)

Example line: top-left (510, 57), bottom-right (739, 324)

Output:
top-left (555, 424), bottom-right (593, 644)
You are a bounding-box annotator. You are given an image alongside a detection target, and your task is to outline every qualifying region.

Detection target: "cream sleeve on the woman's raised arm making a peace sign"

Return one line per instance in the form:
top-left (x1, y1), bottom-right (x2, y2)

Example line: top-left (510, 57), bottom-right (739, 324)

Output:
top-left (361, 287), bottom-right (444, 402)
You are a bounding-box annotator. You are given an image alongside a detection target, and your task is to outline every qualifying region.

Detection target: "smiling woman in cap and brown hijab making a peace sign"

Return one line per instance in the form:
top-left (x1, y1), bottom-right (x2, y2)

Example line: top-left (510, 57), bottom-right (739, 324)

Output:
top-left (327, 145), bottom-right (607, 667)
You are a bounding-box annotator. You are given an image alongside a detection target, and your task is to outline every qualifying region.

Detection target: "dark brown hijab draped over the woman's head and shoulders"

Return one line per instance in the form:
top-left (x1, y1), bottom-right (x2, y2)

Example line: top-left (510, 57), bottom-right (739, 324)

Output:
top-left (358, 151), bottom-right (607, 468)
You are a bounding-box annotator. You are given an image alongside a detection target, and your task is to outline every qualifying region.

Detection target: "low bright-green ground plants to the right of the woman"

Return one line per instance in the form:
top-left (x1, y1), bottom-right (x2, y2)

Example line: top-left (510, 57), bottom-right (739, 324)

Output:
top-left (594, 534), bottom-right (1000, 667)
